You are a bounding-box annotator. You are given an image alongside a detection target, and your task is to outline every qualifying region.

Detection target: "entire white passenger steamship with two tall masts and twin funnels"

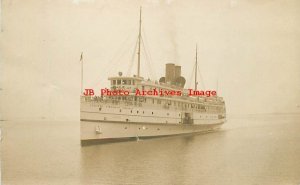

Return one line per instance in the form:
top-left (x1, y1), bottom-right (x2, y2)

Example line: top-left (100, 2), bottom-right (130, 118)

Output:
top-left (80, 7), bottom-right (226, 145)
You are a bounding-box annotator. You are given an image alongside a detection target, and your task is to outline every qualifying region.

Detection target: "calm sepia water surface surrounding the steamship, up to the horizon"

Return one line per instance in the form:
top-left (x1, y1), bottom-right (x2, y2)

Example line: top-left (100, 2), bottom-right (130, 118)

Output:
top-left (1, 115), bottom-right (300, 185)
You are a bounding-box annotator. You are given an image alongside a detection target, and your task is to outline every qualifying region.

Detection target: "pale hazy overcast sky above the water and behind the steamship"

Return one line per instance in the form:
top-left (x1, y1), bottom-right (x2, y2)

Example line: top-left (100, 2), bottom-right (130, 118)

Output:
top-left (0, 0), bottom-right (300, 120)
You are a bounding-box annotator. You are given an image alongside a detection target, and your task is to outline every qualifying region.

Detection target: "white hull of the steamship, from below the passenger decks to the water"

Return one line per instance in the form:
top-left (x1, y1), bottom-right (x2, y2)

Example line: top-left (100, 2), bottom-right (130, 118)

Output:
top-left (80, 107), bottom-right (225, 145)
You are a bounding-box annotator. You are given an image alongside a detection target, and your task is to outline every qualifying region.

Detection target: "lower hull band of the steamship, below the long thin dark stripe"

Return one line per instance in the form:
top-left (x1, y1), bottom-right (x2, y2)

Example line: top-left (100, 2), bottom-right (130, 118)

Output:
top-left (80, 119), bottom-right (225, 146)
